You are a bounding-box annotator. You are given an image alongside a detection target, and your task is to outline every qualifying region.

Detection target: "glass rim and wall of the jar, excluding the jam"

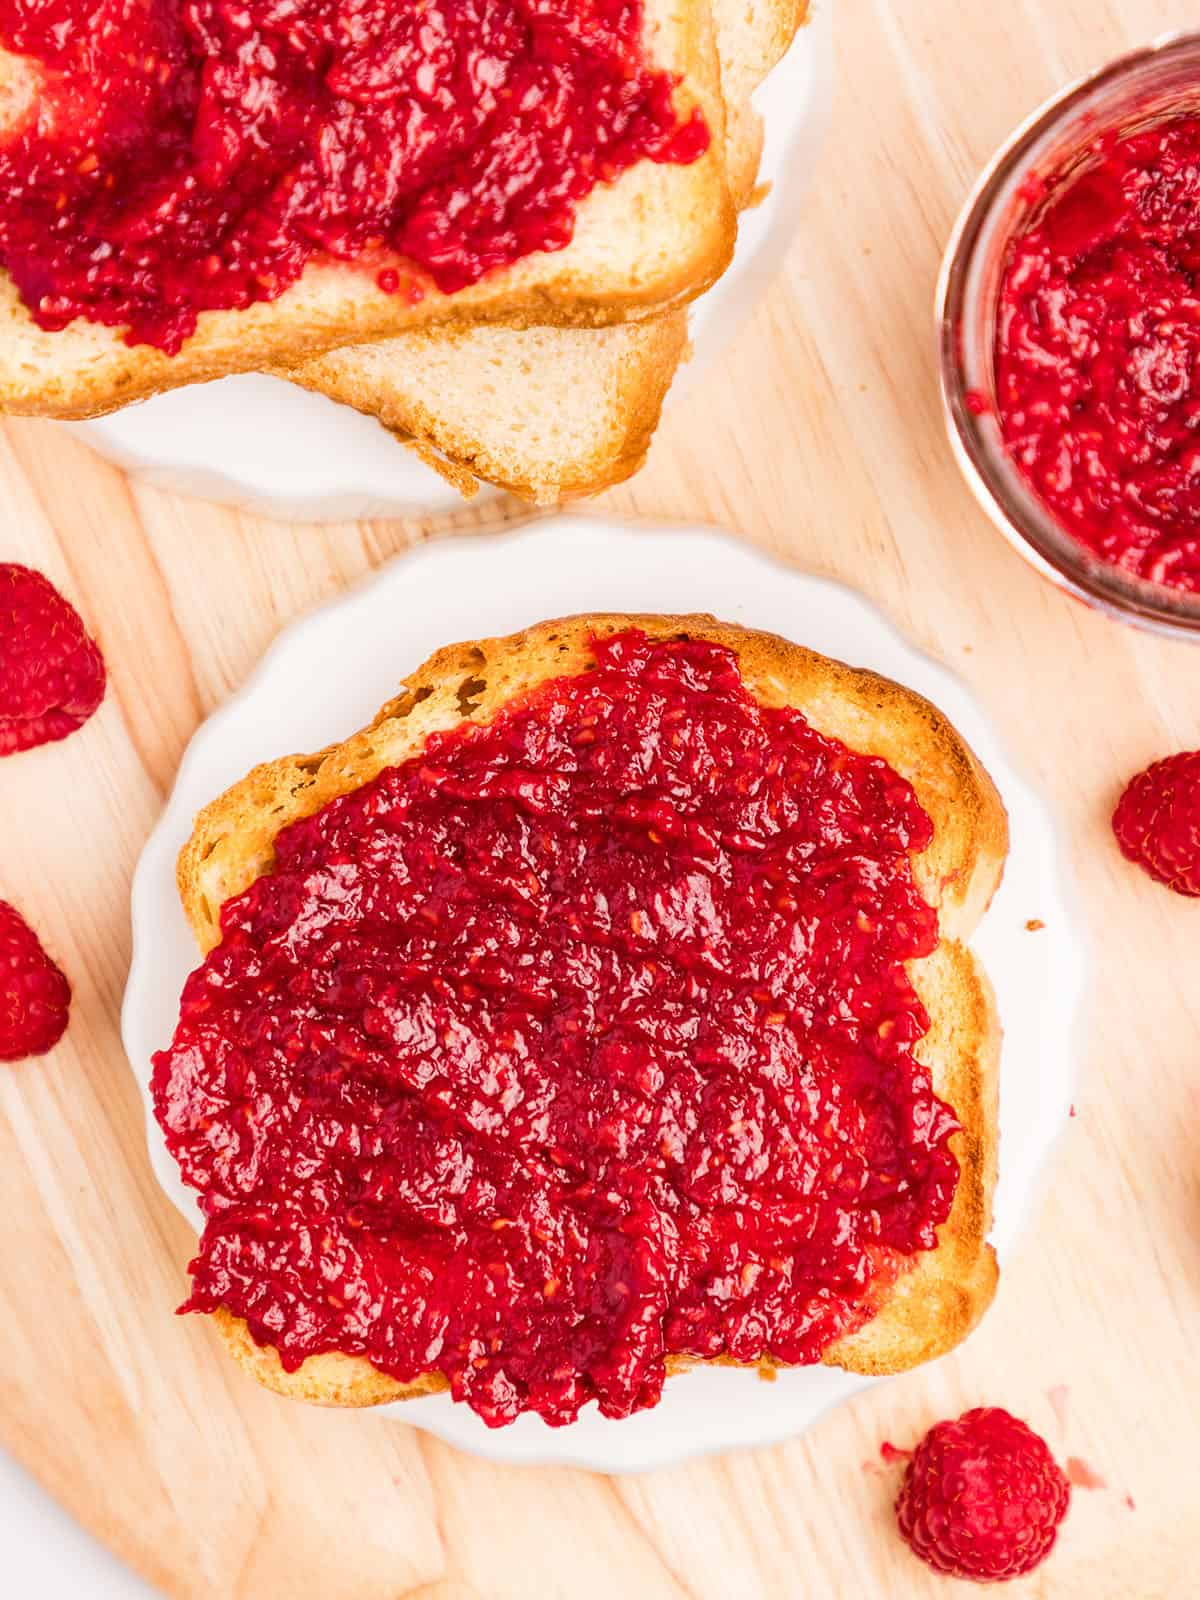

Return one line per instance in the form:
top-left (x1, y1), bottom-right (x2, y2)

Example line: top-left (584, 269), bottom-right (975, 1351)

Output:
top-left (938, 32), bottom-right (1200, 640)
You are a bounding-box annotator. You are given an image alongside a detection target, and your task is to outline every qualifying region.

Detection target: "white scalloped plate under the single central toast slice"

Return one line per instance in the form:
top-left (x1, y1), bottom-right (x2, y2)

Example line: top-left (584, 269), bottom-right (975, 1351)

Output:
top-left (122, 518), bottom-right (1083, 1472)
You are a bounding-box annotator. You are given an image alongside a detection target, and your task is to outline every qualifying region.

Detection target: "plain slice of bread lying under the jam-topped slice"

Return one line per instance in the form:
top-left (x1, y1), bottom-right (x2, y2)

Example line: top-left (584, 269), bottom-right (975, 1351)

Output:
top-left (282, 0), bottom-right (806, 506)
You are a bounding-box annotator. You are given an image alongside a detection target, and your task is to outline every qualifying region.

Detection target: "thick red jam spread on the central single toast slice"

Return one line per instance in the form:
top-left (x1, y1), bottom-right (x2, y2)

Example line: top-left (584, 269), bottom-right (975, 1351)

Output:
top-left (154, 632), bottom-right (958, 1426)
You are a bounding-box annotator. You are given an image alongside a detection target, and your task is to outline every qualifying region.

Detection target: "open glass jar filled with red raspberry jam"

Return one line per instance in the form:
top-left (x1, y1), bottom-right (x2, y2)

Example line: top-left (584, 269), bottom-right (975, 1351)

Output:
top-left (938, 32), bottom-right (1200, 638)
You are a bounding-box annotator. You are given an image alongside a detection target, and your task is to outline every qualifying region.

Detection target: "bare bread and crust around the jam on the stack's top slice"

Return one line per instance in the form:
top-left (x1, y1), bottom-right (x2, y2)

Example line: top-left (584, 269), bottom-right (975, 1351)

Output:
top-left (0, 0), bottom-right (736, 418)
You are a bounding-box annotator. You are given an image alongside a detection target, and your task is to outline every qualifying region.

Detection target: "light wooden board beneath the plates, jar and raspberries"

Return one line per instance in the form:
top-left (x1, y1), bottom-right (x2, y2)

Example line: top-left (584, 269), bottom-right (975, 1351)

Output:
top-left (0, 0), bottom-right (1200, 1600)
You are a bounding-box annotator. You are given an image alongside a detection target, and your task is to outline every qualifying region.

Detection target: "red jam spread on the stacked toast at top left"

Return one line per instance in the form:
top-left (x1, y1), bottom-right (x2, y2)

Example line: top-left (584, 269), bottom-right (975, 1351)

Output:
top-left (0, 0), bottom-right (709, 354)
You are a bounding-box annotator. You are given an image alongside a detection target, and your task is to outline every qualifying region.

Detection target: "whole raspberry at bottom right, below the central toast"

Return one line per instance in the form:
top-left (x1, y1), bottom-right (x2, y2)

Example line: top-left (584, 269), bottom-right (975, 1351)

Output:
top-left (896, 1406), bottom-right (1070, 1582)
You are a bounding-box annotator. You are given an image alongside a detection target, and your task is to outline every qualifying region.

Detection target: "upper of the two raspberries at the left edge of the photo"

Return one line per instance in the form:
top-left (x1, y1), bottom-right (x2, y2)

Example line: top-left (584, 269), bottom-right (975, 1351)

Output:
top-left (0, 562), bottom-right (104, 755)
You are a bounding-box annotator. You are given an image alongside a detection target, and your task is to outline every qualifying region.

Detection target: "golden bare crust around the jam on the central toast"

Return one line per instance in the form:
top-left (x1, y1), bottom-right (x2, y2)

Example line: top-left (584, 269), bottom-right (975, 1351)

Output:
top-left (178, 614), bottom-right (1008, 1406)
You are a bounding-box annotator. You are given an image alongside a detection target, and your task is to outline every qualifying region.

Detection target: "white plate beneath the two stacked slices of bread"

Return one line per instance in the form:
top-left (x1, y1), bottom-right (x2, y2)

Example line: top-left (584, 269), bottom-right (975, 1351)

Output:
top-left (62, 0), bottom-right (834, 522)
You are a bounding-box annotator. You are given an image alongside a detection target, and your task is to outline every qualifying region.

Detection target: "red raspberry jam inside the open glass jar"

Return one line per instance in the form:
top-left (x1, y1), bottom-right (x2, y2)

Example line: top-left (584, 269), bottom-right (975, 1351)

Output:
top-left (995, 118), bottom-right (1200, 592)
